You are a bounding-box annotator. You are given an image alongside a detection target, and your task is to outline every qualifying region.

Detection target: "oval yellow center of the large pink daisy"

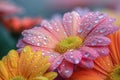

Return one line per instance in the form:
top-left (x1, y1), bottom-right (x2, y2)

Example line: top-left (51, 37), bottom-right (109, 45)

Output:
top-left (55, 36), bottom-right (82, 54)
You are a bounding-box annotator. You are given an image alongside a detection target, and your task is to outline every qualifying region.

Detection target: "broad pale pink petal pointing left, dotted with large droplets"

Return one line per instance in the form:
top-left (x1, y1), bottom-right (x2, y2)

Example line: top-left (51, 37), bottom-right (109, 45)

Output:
top-left (22, 27), bottom-right (58, 48)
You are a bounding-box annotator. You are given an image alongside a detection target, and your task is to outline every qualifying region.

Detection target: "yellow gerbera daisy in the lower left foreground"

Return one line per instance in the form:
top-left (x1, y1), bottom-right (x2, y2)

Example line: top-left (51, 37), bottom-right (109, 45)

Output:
top-left (0, 46), bottom-right (57, 80)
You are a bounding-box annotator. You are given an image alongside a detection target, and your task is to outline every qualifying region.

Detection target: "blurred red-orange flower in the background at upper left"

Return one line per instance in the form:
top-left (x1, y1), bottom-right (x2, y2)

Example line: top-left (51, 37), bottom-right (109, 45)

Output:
top-left (3, 17), bottom-right (41, 33)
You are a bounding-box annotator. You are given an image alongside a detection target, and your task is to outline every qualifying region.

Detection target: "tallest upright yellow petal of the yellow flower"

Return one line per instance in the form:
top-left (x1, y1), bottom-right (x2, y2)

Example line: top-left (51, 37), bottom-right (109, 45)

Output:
top-left (18, 46), bottom-right (35, 75)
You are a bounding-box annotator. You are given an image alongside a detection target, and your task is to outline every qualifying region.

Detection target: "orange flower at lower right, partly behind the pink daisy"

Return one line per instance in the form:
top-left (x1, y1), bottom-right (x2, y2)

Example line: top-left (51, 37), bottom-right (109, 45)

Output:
top-left (68, 30), bottom-right (120, 80)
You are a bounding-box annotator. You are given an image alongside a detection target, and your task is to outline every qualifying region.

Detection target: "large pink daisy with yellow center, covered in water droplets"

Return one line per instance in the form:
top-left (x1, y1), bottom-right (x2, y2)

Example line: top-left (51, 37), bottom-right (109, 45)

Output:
top-left (17, 11), bottom-right (118, 78)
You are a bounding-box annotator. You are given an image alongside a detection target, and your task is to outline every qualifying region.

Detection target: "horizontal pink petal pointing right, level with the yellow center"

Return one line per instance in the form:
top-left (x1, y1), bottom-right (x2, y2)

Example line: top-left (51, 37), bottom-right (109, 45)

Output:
top-left (84, 36), bottom-right (111, 46)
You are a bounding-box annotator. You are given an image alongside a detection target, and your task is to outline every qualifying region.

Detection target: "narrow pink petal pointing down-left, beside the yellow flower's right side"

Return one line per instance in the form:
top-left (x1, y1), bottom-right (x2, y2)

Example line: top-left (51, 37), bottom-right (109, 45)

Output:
top-left (49, 56), bottom-right (64, 71)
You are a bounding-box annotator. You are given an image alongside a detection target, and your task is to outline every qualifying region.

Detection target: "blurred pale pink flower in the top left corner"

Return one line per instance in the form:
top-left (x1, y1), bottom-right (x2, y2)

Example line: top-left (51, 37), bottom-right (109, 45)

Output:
top-left (0, 0), bottom-right (21, 17)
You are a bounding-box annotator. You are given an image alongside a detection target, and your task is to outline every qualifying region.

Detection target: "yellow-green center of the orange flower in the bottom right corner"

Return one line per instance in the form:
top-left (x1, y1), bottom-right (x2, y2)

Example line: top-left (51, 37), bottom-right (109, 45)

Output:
top-left (109, 66), bottom-right (120, 80)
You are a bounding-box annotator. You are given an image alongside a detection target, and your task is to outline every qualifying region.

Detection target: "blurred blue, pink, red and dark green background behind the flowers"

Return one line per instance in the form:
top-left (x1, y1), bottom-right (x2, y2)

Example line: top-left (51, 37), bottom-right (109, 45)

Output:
top-left (0, 0), bottom-right (120, 58)
